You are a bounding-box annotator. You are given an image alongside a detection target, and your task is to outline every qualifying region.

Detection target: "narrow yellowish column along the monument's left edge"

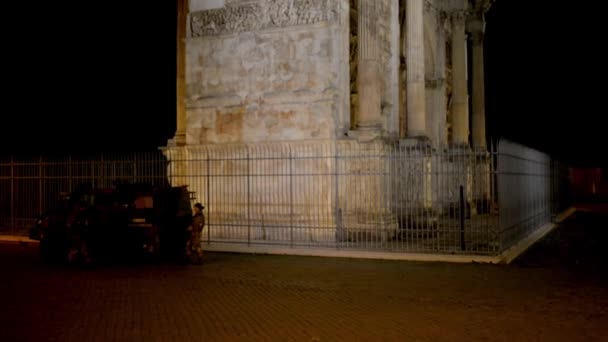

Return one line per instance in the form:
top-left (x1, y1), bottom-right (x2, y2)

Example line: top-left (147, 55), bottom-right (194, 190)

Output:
top-left (173, 0), bottom-right (188, 145)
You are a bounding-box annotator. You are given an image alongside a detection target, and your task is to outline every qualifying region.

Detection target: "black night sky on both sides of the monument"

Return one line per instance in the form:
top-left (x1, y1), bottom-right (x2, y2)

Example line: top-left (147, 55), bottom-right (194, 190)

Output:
top-left (0, 0), bottom-right (607, 164)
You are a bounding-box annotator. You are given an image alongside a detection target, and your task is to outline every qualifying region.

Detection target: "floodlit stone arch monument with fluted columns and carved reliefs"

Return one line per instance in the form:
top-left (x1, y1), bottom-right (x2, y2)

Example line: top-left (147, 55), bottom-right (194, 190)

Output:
top-left (164, 0), bottom-right (492, 246)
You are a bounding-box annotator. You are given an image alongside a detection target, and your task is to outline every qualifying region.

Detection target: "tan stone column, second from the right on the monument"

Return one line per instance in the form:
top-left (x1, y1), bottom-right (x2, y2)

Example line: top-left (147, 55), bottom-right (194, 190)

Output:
top-left (452, 11), bottom-right (469, 145)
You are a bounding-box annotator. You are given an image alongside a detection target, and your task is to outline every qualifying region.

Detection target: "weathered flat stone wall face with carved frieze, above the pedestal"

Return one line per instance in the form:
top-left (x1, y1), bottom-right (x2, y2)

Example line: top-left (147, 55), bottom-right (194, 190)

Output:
top-left (186, 0), bottom-right (345, 144)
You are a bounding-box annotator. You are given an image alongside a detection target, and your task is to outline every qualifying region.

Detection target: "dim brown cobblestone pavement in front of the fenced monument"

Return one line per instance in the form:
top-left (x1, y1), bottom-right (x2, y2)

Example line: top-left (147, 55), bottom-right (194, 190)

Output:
top-left (0, 214), bottom-right (608, 341)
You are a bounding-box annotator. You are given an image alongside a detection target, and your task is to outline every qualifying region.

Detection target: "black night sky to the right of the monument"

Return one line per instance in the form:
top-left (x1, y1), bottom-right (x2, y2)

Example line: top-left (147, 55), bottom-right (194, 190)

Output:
top-left (485, 0), bottom-right (608, 166)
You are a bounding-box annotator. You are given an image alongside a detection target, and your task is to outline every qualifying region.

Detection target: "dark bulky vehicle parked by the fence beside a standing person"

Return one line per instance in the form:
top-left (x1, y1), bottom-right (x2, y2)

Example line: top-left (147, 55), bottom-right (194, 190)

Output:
top-left (30, 183), bottom-right (192, 264)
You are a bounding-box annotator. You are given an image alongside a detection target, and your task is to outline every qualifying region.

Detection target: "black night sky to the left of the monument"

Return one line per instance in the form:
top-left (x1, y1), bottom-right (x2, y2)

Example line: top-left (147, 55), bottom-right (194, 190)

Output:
top-left (0, 1), bottom-right (176, 153)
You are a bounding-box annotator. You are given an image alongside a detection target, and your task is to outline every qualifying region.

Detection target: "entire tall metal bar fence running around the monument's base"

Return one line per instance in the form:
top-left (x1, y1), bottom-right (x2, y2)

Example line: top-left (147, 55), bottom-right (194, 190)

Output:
top-left (0, 142), bottom-right (568, 255)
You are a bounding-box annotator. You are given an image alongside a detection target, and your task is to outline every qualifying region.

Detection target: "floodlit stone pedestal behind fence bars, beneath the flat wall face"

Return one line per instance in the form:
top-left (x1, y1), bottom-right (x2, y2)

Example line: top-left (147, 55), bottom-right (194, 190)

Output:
top-left (165, 140), bottom-right (398, 246)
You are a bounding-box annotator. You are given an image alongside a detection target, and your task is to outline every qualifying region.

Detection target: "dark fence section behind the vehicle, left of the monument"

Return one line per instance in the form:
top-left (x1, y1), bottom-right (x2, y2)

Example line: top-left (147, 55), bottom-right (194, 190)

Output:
top-left (0, 152), bottom-right (168, 234)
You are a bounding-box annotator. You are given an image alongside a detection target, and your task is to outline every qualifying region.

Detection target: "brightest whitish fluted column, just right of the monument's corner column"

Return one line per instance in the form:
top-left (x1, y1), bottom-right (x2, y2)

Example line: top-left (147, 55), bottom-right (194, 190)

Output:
top-left (405, 0), bottom-right (428, 137)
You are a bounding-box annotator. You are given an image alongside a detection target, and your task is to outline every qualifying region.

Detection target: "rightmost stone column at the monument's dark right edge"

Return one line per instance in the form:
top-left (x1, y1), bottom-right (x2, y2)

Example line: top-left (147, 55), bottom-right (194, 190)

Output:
top-left (468, 17), bottom-right (487, 147)
